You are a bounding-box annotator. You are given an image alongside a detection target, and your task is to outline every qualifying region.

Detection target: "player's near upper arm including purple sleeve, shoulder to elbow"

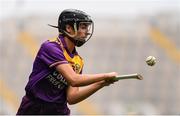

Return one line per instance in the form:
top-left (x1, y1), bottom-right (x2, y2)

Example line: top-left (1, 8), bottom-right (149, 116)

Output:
top-left (38, 42), bottom-right (82, 86)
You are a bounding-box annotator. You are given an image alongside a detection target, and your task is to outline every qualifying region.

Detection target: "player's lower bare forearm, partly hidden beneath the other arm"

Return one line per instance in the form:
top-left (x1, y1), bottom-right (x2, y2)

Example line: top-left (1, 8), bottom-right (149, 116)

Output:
top-left (67, 81), bottom-right (114, 105)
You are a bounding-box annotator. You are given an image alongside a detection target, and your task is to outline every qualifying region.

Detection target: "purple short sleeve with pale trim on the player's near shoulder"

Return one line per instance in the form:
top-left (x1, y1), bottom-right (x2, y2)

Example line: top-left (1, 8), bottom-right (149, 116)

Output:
top-left (38, 41), bottom-right (68, 67)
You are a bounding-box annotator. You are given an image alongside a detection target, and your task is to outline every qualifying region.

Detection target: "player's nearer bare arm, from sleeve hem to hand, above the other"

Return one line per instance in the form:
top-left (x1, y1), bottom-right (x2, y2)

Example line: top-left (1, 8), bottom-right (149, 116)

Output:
top-left (56, 64), bottom-right (117, 87)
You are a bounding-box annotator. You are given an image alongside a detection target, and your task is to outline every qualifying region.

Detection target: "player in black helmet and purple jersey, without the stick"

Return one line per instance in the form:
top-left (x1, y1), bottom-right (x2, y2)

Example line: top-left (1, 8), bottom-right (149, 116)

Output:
top-left (17, 9), bottom-right (117, 115)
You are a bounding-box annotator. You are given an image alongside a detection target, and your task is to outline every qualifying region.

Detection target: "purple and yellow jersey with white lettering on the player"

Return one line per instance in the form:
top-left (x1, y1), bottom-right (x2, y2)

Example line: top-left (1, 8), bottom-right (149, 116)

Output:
top-left (16, 37), bottom-right (83, 114)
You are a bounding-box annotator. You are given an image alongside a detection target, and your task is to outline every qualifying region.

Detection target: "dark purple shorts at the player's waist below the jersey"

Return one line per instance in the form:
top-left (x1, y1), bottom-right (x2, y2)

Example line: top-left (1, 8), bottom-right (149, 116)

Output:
top-left (17, 96), bottom-right (70, 115)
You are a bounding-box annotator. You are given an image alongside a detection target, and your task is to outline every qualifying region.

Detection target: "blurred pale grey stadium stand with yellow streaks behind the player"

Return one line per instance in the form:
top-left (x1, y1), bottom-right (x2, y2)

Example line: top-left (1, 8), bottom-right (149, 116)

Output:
top-left (0, 0), bottom-right (180, 115)
